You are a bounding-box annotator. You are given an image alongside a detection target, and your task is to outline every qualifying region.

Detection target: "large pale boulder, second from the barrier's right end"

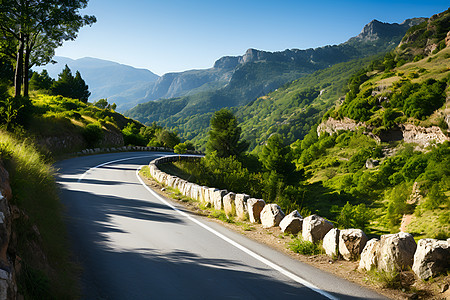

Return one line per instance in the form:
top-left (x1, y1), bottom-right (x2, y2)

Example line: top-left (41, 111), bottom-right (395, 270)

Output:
top-left (377, 232), bottom-right (417, 272)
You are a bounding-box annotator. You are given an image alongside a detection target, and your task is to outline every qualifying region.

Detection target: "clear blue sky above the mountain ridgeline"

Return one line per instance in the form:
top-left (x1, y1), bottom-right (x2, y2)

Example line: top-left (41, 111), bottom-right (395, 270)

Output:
top-left (56, 0), bottom-right (450, 75)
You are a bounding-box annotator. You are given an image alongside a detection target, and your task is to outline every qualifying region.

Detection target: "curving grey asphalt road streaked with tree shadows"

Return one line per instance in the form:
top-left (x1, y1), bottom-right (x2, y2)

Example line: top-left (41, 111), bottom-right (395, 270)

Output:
top-left (55, 152), bottom-right (383, 300)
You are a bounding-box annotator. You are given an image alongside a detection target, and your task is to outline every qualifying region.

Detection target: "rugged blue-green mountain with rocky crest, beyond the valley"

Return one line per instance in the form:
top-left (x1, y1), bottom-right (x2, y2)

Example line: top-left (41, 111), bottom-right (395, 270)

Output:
top-left (125, 18), bottom-right (424, 144)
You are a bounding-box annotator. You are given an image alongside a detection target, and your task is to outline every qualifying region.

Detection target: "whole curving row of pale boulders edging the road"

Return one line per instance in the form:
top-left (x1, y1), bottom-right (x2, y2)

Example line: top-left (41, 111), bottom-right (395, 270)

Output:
top-left (144, 155), bottom-right (444, 278)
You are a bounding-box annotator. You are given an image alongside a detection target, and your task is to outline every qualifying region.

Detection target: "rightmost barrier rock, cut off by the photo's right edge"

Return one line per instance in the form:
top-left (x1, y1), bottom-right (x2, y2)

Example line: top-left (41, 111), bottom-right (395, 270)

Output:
top-left (412, 239), bottom-right (450, 280)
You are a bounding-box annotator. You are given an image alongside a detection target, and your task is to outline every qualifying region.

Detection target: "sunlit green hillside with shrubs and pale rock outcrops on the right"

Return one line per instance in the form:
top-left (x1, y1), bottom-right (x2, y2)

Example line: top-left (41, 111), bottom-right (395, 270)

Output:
top-left (291, 11), bottom-right (450, 239)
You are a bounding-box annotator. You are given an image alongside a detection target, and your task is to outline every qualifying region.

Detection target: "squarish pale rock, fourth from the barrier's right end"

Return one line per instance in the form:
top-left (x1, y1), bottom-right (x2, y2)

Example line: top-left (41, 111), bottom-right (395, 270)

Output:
top-left (339, 229), bottom-right (368, 260)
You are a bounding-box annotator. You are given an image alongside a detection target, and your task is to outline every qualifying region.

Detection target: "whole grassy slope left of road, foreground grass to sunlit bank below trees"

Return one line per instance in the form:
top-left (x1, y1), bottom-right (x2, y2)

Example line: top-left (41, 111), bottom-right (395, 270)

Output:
top-left (0, 92), bottom-right (147, 299)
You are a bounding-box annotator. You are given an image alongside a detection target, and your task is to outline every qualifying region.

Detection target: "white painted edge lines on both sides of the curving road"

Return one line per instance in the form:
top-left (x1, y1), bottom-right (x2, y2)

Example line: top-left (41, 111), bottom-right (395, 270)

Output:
top-left (78, 156), bottom-right (338, 300)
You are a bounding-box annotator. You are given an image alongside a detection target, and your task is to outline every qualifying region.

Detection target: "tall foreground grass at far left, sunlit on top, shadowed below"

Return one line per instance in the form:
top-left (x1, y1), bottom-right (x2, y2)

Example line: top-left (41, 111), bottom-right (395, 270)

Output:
top-left (0, 131), bottom-right (78, 299)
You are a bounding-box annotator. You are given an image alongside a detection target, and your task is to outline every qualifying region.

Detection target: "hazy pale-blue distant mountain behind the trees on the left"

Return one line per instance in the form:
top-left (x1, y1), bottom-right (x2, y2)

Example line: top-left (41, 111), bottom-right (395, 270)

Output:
top-left (33, 56), bottom-right (159, 111)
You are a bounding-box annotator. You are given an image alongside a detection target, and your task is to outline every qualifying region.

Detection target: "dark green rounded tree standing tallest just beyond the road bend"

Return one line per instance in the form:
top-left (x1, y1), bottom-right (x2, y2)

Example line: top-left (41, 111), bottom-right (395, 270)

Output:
top-left (206, 108), bottom-right (249, 157)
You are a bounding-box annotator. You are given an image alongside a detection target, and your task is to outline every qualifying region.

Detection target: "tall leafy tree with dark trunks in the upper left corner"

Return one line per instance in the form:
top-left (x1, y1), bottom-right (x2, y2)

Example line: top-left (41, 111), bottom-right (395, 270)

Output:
top-left (0, 0), bottom-right (96, 96)
